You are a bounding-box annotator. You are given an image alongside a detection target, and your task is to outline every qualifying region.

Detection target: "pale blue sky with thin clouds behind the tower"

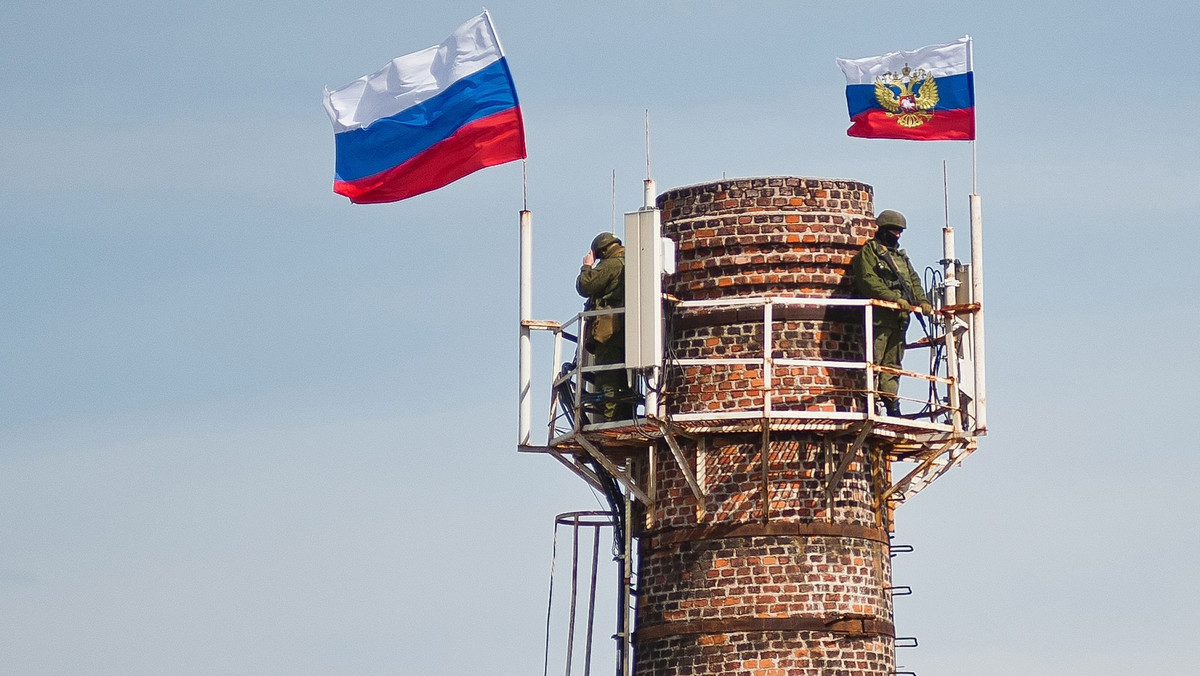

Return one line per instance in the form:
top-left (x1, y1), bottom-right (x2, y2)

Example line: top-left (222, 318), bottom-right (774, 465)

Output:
top-left (0, 0), bottom-right (1200, 676)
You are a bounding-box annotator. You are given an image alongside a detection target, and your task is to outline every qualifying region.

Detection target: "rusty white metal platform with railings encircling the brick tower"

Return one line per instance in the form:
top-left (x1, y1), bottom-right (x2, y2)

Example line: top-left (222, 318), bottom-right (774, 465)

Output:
top-left (518, 297), bottom-right (986, 513)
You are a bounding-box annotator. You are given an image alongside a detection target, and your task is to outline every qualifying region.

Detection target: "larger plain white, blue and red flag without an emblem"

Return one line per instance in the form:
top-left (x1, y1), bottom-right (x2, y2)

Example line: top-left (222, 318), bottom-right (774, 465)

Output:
top-left (325, 12), bottom-right (526, 204)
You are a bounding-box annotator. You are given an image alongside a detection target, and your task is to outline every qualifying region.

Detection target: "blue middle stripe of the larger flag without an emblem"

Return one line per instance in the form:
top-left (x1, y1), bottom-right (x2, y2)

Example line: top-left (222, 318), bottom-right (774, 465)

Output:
top-left (334, 59), bottom-right (517, 181)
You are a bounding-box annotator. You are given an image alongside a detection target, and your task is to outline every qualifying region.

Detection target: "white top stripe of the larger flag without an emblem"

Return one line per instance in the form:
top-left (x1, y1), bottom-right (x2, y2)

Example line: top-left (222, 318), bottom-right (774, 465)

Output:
top-left (325, 13), bottom-right (502, 133)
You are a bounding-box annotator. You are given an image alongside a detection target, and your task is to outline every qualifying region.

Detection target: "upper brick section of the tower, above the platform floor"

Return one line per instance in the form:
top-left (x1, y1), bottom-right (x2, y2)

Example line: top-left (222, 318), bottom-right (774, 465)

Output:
top-left (659, 177), bottom-right (875, 413)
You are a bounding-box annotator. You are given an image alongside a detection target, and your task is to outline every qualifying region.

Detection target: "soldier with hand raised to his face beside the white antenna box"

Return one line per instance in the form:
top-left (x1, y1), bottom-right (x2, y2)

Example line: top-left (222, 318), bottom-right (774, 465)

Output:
top-left (575, 233), bottom-right (632, 420)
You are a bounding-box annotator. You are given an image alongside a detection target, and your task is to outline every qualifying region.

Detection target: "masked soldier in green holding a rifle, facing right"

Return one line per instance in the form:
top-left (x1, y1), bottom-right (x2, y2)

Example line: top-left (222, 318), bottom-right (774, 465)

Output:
top-left (850, 209), bottom-right (934, 415)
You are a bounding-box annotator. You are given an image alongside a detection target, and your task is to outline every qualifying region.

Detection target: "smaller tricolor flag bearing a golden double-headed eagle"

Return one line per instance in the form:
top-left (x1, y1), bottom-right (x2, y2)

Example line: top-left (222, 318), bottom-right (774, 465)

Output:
top-left (838, 37), bottom-right (976, 140)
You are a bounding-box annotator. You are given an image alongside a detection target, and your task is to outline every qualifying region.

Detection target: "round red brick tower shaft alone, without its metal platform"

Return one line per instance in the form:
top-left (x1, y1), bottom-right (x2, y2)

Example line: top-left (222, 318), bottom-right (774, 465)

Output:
top-left (634, 178), bottom-right (895, 676)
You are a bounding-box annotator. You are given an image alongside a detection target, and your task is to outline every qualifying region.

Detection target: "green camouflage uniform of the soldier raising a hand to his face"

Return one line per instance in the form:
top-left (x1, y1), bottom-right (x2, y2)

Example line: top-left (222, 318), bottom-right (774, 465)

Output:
top-left (575, 239), bottom-right (632, 420)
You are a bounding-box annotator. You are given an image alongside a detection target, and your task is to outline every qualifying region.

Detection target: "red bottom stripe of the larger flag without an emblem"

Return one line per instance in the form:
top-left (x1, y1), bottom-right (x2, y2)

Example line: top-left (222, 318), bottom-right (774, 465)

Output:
top-left (334, 107), bottom-right (526, 204)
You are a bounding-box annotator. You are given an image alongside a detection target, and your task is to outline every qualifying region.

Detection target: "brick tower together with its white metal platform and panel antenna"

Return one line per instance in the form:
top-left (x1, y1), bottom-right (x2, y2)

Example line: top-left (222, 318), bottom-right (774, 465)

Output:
top-left (520, 177), bottom-right (985, 676)
